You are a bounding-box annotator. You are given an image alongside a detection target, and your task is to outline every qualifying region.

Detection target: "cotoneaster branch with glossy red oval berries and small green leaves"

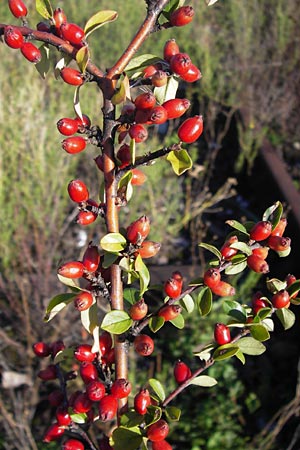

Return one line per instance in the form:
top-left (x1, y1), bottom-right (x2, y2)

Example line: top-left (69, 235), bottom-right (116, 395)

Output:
top-left (0, 0), bottom-right (300, 450)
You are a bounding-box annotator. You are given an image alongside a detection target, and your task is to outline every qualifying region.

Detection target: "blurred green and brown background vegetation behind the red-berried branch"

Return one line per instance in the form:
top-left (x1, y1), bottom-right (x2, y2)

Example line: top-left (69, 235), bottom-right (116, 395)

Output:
top-left (0, 0), bottom-right (300, 450)
